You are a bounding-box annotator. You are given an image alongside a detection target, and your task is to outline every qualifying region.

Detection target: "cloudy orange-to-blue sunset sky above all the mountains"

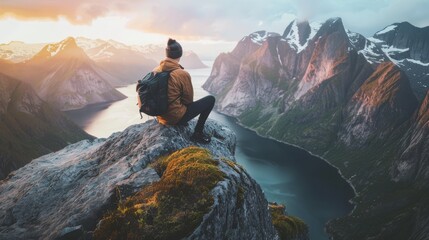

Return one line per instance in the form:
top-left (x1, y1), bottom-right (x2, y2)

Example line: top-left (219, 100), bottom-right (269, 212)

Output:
top-left (0, 0), bottom-right (429, 59)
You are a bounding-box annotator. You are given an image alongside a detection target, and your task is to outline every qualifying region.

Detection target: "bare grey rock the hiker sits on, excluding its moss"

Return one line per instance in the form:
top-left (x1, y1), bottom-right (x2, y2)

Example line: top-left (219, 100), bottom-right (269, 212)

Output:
top-left (0, 121), bottom-right (290, 239)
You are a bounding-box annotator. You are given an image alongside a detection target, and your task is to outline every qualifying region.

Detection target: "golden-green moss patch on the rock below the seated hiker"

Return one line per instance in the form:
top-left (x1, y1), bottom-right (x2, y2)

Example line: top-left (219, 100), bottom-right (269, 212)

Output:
top-left (94, 147), bottom-right (225, 240)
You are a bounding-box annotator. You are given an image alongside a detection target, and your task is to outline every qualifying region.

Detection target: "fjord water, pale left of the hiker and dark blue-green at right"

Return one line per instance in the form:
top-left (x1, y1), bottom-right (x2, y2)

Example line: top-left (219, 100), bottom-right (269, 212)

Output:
top-left (67, 63), bottom-right (353, 240)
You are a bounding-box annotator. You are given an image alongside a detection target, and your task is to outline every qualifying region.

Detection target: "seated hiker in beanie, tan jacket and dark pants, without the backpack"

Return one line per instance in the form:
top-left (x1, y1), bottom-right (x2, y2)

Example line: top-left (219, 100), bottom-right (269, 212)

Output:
top-left (154, 38), bottom-right (215, 143)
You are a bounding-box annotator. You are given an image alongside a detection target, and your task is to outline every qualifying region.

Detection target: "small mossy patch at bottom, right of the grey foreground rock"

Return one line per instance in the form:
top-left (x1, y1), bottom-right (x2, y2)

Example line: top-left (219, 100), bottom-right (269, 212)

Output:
top-left (268, 204), bottom-right (308, 240)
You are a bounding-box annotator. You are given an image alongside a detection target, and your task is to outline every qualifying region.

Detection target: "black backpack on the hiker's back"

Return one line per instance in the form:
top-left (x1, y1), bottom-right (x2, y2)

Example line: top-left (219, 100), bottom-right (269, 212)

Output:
top-left (136, 71), bottom-right (170, 116)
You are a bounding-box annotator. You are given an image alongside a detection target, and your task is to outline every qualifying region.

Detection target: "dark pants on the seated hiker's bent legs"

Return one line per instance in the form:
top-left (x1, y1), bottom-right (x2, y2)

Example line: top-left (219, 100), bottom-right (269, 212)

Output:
top-left (177, 96), bottom-right (215, 133)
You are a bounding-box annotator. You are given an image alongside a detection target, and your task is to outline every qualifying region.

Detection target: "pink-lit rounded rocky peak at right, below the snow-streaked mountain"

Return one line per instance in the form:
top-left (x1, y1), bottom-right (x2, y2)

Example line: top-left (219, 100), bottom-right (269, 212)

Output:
top-left (338, 62), bottom-right (418, 148)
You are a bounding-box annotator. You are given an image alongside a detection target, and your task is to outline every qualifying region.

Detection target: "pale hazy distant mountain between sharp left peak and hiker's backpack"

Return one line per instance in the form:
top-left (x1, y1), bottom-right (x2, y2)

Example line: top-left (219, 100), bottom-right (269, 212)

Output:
top-left (77, 37), bottom-right (157, 87)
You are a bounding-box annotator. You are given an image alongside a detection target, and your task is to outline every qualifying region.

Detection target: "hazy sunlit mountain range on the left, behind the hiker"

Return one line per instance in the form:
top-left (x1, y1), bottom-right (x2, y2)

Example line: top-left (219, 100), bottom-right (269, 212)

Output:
top-left (0, 37), bottom-right (207, 179)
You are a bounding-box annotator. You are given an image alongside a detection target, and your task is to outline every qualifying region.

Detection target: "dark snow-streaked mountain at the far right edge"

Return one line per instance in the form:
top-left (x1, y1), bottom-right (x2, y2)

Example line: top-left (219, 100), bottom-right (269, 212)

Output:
top-left (370, 22), bottom-right (429, 99)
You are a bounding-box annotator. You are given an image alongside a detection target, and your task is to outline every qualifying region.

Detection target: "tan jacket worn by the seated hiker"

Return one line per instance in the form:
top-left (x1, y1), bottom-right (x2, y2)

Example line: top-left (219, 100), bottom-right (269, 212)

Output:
top-left (153, 58), bottom-right (194, 125)
